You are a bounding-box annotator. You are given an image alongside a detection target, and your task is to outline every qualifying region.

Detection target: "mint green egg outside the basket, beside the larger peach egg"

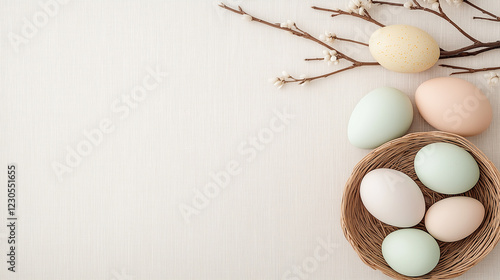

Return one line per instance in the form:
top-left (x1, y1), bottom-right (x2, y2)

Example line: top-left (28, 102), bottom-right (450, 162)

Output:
top-left (347, 87), bottom-right (413, 149)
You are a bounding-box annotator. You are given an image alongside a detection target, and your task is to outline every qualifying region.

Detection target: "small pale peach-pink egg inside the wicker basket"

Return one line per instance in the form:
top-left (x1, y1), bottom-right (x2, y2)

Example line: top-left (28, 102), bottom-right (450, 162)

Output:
top-left (425, 196), bottom-right (484, 242)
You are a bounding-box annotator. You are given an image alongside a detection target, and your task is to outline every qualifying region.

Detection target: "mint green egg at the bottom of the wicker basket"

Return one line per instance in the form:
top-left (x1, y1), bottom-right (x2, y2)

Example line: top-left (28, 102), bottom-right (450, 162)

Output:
top-left (382, 228), bottom-right (441, 277)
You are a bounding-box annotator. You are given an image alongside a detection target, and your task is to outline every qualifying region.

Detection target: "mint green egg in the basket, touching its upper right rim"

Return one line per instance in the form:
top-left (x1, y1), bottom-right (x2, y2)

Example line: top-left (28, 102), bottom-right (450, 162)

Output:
top-left (414, 143), bottom-right (479, 194)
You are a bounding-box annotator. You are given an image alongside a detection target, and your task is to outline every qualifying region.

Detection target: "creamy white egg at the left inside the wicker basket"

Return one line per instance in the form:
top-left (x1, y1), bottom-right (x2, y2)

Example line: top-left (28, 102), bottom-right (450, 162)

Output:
top-left (360, 168), bottom-right (425, 227)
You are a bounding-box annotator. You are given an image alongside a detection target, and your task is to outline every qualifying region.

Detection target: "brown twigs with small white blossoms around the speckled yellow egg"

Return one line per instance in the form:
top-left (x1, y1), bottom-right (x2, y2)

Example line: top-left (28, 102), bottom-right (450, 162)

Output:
top-left (219, 0), bottom-right (500, 88)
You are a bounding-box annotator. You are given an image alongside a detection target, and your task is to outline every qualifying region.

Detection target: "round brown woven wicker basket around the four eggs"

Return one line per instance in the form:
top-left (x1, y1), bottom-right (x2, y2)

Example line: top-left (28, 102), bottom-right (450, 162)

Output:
top-left (341, 131), bottom-right (500, 279)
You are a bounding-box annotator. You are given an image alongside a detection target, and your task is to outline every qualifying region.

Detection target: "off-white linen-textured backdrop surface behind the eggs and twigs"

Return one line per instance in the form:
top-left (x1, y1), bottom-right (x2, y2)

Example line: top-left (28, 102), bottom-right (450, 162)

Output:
top-left (0, 0), bottom-right (500, 280)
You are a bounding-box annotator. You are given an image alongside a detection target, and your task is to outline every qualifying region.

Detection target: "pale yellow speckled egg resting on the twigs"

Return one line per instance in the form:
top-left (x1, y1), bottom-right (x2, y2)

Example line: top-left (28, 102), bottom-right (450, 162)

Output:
top-left (369, 24), bottom-right (440, 73)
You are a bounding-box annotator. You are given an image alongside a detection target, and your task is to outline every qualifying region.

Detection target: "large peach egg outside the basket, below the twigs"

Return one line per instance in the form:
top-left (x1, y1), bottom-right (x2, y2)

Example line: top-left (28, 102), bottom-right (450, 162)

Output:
top-left (415, 77), bottom-right (493, 136)
